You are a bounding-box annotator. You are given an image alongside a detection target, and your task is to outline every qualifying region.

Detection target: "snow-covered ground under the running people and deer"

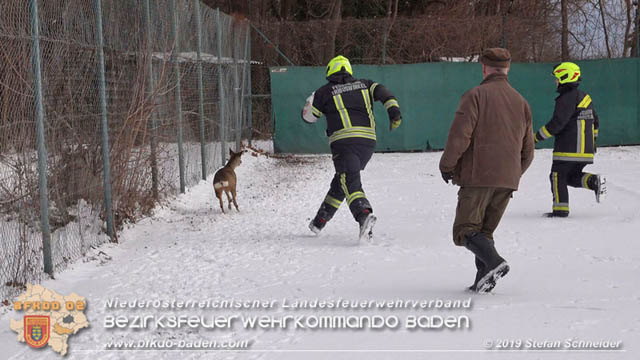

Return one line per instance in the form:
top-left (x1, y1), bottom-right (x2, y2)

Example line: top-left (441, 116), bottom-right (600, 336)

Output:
top-left (0, 142), bottom-right (640, 359)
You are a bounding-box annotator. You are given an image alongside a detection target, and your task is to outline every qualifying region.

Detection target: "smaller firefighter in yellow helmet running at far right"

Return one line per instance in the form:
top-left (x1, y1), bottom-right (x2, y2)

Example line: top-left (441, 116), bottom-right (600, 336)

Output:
top-left (535, 62), bottom-right (605, 217)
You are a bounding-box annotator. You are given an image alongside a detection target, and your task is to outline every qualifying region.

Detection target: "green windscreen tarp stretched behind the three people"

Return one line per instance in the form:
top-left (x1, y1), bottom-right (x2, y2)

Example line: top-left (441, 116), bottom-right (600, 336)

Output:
top-left (271, 58), bottom-right (640, 153)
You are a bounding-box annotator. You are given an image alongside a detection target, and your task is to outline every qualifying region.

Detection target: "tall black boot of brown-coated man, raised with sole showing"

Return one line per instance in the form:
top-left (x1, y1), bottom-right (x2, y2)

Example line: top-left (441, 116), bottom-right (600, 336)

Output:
top-left (464, 233), bottom-right (509, 293)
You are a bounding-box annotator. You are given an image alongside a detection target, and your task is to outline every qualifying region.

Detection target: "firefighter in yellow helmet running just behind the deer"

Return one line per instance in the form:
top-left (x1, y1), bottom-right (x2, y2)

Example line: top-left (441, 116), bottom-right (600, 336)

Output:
top-left (302, 56), bottom-right (402, 240)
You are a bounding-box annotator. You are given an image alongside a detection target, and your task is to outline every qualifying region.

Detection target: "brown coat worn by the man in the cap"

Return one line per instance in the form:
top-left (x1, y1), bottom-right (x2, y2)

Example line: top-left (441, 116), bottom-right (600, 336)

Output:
top-left (440, 74), bottom-right (534, 190)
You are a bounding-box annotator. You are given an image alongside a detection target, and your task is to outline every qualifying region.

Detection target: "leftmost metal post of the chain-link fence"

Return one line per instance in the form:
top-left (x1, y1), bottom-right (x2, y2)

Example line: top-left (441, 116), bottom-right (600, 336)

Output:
top-left (31, 0), bottom-right (53, 277)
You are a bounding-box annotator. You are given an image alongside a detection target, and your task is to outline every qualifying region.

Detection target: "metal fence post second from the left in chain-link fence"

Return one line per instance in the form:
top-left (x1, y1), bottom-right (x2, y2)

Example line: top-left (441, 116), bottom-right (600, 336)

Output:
top-left (94, 0), bottom-right (117, 241)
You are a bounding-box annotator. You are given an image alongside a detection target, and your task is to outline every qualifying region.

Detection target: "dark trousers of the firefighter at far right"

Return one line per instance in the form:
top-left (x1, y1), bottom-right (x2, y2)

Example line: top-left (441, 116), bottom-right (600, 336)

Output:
top-left (549, 161), bottom-right (595, 211)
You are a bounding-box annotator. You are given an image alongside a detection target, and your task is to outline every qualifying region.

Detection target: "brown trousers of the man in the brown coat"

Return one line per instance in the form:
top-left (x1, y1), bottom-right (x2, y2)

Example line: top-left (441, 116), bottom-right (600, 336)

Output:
top-left (453, 187), bottom-right (513, 246)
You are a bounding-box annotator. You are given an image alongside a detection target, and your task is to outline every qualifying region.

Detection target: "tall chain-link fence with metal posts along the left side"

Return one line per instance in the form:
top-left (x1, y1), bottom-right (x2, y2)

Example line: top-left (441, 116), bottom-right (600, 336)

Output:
top-left (0, 0), bottom-right (251, 300)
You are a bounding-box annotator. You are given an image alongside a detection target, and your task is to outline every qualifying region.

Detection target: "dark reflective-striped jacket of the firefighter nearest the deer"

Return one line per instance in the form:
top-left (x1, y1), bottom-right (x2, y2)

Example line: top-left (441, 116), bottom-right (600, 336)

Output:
top-left (303, 71), bottom-right (401, 144)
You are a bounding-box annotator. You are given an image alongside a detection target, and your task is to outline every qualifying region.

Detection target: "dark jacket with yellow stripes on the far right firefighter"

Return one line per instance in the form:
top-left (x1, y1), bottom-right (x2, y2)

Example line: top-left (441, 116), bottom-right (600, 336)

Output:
top-left (536, 83), bottom-right (599, 163)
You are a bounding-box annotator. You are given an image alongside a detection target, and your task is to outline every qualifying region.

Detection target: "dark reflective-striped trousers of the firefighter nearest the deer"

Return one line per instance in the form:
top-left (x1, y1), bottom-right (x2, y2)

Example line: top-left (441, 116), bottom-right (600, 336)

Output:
top-left (316, 142), bottom-right (375, 222)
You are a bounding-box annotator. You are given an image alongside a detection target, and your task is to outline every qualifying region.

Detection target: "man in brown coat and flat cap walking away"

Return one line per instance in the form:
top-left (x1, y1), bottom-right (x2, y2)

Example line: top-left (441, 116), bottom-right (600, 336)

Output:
top-left (440, 48), bottom-right (534, 292)
